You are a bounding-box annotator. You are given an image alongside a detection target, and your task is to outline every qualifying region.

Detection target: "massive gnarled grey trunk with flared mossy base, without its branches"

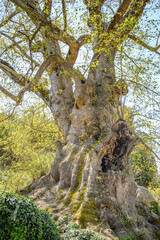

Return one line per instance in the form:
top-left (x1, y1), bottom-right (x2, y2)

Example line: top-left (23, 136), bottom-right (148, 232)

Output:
top-left (21, 50), bottom-right (157, 239)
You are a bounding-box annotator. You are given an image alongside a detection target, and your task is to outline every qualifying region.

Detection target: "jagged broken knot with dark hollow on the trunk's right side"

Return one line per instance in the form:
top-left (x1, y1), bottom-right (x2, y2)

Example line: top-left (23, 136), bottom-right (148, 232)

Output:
top-left (99, 119), bottom-right (139, 172)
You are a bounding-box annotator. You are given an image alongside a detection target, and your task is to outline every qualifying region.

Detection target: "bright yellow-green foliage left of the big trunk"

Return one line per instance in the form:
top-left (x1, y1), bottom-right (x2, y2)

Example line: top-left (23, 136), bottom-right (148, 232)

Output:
top-left (0, 106), bottom-right (60, 191)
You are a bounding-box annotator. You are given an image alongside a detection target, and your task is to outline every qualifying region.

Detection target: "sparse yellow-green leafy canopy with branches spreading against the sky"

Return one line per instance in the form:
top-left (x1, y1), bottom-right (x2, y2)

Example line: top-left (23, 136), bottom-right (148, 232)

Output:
top-left (0, 0), bottom-right (160, 169)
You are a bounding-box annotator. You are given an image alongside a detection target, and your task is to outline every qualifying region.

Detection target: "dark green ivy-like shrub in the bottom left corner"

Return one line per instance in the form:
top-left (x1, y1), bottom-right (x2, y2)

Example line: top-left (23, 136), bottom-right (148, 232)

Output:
top-left (0, 191), bottom-right (61, 240)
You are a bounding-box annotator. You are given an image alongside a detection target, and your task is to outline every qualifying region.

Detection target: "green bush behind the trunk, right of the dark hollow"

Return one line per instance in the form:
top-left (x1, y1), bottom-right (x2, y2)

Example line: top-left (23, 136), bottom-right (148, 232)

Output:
top-left (130, 144), bottom-right (157, 187)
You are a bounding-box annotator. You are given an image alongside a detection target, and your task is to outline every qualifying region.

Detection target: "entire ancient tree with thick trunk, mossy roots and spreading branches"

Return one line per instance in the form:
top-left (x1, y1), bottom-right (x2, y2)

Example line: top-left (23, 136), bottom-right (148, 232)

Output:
top-left (0, 0), bottom-right (160, 239)
